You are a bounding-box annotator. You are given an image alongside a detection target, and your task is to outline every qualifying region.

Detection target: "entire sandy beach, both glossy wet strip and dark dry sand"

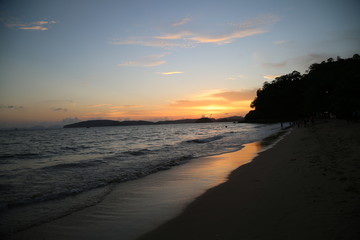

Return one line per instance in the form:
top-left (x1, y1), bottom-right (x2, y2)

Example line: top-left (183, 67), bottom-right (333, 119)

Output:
top-left (11, 120), bottom-right (360, 240)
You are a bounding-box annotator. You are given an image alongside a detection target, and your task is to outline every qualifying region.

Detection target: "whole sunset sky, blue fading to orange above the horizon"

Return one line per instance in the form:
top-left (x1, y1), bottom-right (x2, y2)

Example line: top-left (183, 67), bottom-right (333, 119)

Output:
top-left (0, 0), bottom-right (360, 128)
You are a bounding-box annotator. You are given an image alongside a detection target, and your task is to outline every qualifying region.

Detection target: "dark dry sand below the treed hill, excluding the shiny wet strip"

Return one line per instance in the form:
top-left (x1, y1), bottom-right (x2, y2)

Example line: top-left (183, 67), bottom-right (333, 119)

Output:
top-left (141, 120), bottom-right (360, 240)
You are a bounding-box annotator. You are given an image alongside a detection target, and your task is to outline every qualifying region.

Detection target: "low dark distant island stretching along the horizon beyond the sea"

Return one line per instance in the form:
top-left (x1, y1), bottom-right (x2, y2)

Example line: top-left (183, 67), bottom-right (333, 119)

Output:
top-left (64, 116), bottom-right (244, 128)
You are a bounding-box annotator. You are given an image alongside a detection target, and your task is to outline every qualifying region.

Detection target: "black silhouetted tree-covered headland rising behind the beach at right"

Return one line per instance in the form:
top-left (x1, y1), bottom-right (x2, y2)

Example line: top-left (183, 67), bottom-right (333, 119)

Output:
top-left (245, 54), bottom-right (360, 122)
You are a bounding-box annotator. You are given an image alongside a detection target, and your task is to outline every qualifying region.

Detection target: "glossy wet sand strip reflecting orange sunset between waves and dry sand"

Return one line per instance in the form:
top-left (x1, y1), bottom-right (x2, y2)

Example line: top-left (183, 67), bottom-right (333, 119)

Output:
top-left (10, 126), bottom-right (288, 239)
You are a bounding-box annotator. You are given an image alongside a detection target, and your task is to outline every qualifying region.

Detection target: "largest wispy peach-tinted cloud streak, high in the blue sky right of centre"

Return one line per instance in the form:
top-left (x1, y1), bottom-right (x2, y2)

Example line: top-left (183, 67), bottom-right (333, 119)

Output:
top-left (111, 15), bottom-right (280, 48)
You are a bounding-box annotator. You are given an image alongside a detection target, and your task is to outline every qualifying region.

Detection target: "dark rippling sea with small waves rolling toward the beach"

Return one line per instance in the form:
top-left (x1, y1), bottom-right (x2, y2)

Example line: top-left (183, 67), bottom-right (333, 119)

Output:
top-left (0, 123), bottom-right (280, 234)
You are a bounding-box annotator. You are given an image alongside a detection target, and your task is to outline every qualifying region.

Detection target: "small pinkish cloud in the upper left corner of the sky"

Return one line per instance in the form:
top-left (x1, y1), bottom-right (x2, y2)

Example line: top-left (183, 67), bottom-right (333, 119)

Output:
top-left (0, 15), bottom-right (57, 31)
